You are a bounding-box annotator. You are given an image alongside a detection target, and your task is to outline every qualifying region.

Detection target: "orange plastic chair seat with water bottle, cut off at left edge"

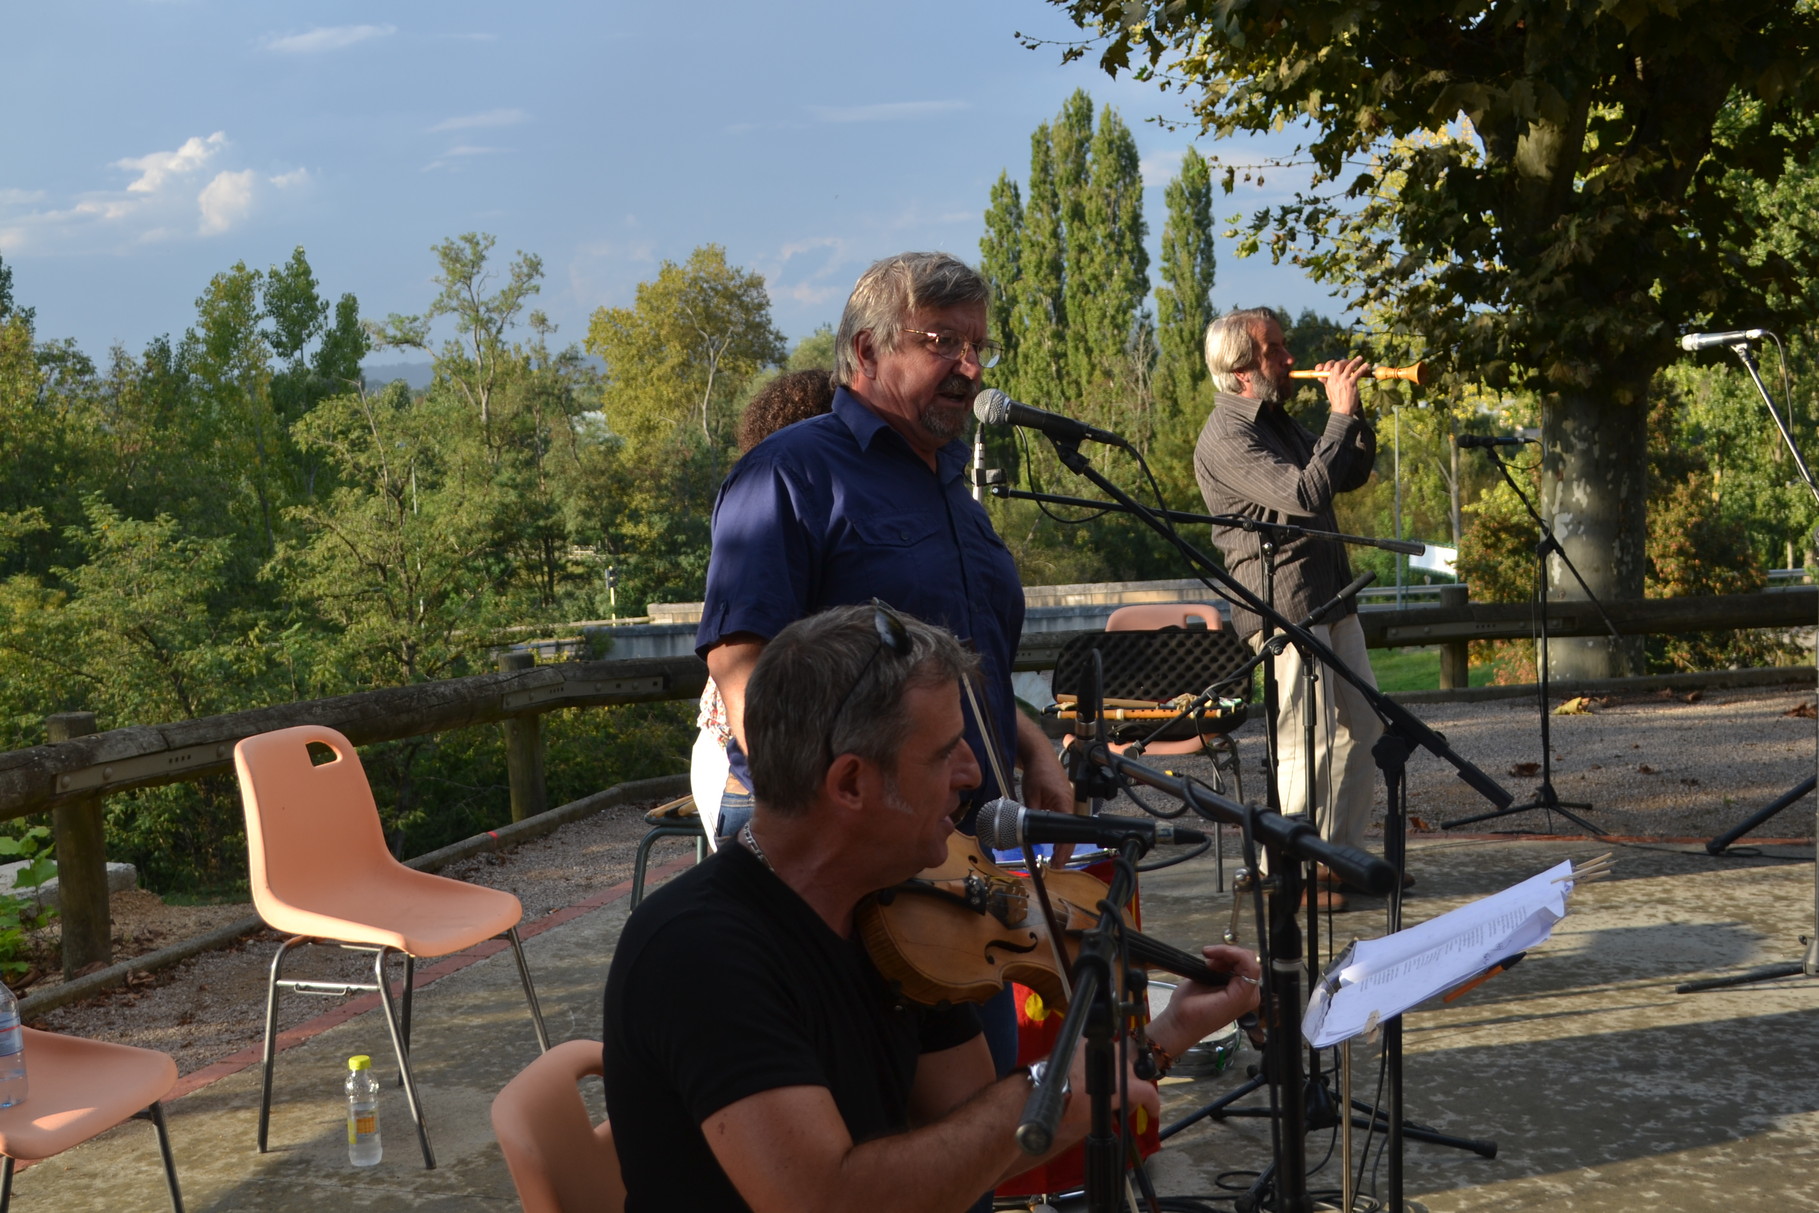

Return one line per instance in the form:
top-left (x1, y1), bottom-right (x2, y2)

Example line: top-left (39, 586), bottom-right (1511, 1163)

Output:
top-left (0, 1028), bottom-right (184, 1213)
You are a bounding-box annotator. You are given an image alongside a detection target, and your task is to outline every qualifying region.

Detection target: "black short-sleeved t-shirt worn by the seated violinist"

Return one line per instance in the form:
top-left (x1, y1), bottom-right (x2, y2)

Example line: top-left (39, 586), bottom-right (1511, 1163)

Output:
top-left (604, 846), bottom-right (979, 1213)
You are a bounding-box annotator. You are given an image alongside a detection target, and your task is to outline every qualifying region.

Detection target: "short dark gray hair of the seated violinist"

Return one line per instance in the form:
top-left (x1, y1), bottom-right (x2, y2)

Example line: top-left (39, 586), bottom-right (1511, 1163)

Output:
top-left (746, 604), bottom-right (979, 817)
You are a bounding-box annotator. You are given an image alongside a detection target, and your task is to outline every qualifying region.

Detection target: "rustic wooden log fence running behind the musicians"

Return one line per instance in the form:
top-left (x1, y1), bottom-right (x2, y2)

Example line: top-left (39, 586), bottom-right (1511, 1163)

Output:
top-left (10, 586), bottom-right (1819, 973)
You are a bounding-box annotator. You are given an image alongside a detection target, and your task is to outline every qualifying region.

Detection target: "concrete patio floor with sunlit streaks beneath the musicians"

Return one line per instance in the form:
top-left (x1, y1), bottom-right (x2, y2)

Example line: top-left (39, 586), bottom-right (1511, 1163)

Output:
top-left (15, 829), bottom-right (1819, 1213)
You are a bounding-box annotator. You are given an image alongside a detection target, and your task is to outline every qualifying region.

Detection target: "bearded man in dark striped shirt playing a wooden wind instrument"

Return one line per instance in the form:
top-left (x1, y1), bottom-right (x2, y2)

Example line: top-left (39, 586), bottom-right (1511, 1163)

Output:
top-left (1193, 307), bottom-right (1382, 909)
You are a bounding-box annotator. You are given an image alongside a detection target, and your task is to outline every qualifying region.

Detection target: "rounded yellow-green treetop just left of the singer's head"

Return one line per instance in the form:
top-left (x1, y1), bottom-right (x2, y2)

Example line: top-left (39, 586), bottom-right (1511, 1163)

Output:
top-left (586, 244), bottom-right (786, 446)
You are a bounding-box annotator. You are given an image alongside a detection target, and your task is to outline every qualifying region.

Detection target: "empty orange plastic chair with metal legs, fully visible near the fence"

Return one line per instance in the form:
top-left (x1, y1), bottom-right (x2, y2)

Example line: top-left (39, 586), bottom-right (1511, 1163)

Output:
top-left (233, 724), bottom-right (549, 1168)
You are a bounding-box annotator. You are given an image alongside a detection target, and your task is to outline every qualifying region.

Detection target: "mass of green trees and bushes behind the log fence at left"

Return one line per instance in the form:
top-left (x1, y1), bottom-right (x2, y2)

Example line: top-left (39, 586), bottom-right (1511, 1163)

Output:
top-left (0, 233), bottom-right (778, 902)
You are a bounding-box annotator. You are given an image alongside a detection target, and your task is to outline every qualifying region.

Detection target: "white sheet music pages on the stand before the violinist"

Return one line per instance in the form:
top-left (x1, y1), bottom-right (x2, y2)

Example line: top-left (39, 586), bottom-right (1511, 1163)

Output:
top-left (1301, 860), bottom-right (1573, 1049)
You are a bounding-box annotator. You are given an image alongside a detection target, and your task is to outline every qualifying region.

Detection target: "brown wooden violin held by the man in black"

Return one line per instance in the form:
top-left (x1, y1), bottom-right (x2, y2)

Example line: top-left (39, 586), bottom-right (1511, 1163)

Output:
top-left (855, 833), bottom-right (1231, 1009)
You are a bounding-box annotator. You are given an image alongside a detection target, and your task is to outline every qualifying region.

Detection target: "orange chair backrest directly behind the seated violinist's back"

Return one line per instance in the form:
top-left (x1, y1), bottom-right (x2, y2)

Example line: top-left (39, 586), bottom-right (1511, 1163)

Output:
top-left (493, 1040), bottom-right (626, 1213)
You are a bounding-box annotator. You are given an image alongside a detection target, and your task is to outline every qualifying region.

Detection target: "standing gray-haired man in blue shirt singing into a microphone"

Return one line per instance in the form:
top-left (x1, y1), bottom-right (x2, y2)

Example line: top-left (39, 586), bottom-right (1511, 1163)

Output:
top-left (695, 253), bottom-right (1073, 851)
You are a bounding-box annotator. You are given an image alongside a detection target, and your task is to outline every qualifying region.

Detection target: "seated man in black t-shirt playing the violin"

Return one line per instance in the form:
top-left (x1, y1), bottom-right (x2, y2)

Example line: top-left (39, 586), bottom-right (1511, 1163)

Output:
top-left (606, 606), bottom-right (1261, 1213)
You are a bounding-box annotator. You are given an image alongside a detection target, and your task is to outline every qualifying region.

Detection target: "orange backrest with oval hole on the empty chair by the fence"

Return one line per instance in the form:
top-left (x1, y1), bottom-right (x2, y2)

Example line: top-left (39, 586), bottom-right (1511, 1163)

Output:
top-left (233, 724), bottom-right (398, 913)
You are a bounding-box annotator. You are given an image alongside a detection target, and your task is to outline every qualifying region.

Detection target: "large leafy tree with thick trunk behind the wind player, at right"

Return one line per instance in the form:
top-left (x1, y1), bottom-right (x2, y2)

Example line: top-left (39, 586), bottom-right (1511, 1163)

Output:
top-left (1053, 0), bottom-right (1819, 677)
